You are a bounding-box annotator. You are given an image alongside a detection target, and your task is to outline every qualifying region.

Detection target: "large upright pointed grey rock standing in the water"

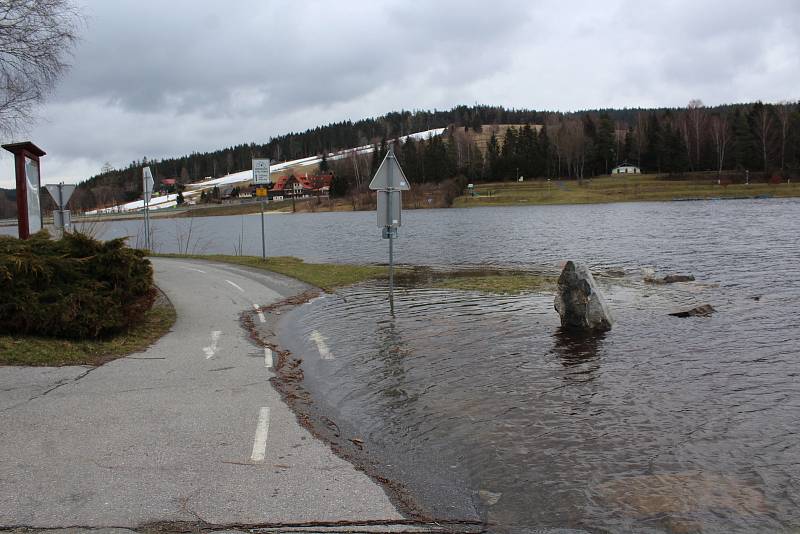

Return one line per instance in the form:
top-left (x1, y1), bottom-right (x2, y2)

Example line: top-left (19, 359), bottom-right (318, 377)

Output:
top-left (555, 261), bottom-right (614, 330)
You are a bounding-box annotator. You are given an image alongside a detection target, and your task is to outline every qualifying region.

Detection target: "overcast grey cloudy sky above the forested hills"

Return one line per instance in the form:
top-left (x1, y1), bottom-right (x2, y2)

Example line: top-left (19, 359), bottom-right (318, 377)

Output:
top-left (0, 0), bottom-right (800, 187)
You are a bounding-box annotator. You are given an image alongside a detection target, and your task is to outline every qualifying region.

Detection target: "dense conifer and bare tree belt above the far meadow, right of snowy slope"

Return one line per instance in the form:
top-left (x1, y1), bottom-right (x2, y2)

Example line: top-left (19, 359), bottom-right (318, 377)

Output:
top-left (324, 100), bottom-right (800, 195)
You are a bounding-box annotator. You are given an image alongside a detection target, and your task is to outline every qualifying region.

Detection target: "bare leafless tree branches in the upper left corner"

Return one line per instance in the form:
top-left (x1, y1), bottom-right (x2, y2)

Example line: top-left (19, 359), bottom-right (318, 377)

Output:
top-left (0, 0), bottom-right (81, 134)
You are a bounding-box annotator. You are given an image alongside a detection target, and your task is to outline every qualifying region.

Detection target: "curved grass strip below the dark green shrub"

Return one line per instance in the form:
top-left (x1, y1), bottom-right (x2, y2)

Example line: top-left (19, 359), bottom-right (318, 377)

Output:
top-left (0, 298), bottom-right (175, 366)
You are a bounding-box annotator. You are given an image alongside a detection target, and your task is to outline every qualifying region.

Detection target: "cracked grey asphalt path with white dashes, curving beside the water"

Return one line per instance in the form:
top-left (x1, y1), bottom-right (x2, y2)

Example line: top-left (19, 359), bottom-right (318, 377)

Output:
top-left (0, 259), bottom-right (402, 528)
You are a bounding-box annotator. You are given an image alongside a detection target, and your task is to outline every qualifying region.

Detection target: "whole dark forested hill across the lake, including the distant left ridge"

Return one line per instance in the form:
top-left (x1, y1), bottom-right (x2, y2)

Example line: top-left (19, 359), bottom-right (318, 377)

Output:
top-left (53, 101), bottom-right (800, 209)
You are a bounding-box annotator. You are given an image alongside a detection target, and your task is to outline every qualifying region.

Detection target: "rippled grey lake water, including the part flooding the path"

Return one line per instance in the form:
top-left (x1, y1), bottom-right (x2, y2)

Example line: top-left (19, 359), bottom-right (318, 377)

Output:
top-left (7, 200), bottom-right (800, 533)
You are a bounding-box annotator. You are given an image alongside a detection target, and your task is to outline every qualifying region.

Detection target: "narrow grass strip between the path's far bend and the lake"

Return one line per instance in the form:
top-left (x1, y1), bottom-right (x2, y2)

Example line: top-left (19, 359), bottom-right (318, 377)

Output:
top-left (151, 254), bottom-right (389, 291)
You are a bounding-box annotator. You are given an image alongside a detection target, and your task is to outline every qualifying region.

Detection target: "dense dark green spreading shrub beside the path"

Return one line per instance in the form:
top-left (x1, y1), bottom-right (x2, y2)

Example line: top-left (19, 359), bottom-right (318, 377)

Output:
top-left (0, 231), bottom-right (155, 339)
